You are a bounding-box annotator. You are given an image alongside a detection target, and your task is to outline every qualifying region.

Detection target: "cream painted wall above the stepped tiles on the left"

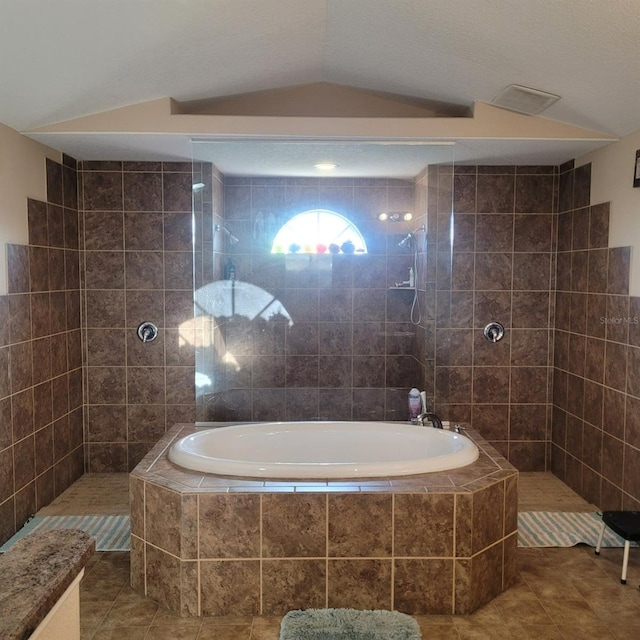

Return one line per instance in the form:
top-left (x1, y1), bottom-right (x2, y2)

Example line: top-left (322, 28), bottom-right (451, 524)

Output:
top-left (0, 124), bottom-right (61, 295)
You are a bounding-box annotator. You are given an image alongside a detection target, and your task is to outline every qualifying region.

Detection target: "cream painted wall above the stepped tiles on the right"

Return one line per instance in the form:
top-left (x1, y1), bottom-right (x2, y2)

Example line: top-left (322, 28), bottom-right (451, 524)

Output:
top-left (576, 131), bottom-right (640, 296)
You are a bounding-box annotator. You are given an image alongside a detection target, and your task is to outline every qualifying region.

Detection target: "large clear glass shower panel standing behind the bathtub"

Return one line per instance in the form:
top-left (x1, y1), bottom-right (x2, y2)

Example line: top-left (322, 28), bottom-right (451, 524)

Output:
top-left (192, 141), bottom-right (454, 421)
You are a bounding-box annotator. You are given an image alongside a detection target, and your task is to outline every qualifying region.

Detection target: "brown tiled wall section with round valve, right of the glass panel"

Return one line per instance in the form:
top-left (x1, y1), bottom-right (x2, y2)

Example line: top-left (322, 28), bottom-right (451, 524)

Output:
top-left (433, 166), bottom-right (558, 471)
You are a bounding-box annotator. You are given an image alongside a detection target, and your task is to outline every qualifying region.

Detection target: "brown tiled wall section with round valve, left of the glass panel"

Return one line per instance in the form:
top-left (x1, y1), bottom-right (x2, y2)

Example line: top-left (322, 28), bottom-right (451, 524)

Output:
top-left (79, 162), bottom-right (199, 472)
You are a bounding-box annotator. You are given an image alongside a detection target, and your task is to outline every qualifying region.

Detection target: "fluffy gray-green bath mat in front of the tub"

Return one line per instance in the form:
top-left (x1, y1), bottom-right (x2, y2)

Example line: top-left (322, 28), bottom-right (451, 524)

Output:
top-left (280, 609), bottom-right (421, 640)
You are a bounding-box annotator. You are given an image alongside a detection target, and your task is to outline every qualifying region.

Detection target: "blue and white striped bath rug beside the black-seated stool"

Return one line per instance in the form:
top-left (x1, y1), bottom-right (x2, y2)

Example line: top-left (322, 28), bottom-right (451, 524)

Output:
top-left (518, 511), bottom-right (635, 547)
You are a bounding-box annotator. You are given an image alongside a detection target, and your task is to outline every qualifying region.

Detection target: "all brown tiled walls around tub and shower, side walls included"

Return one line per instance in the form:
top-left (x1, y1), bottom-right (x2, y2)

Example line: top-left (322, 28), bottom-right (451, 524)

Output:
top-left (6, 150), bottom-right (640, 524)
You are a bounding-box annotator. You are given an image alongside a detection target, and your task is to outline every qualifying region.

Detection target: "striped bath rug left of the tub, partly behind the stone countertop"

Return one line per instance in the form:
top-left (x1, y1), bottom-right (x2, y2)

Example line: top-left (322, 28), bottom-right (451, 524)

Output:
top-left (0, 516), bottom-right (131, 552)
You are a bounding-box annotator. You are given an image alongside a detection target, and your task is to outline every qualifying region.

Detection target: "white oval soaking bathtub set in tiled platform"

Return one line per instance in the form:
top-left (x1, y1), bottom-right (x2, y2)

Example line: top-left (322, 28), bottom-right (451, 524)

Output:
top-left (169, 421), bottom-right (478, 479)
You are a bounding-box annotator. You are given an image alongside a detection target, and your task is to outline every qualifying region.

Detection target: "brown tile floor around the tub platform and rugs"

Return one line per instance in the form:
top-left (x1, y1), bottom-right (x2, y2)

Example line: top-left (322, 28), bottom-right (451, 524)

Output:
top-left (40, 473), bottom-right (640, 640)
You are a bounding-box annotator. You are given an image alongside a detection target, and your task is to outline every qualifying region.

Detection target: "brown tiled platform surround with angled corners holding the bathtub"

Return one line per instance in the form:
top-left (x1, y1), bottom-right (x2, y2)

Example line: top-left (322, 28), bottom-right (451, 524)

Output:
top-left (130, 425), bottom-right (518, 616)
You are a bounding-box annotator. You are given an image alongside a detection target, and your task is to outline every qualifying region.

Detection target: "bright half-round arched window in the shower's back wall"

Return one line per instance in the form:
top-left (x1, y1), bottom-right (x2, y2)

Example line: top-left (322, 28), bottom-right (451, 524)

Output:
top-left (271, 209), bottom-right (367, 253)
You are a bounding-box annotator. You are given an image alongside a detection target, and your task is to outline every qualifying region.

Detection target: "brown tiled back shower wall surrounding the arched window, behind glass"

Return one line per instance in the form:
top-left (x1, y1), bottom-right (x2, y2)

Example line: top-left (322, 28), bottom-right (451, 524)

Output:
top-left (203, 177), bottom-right (424, 420)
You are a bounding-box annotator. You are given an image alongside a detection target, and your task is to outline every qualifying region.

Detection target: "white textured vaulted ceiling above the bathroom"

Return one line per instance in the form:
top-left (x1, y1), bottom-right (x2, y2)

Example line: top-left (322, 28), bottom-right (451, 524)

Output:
top-left (0, 0), bottom-right (640, 173)
